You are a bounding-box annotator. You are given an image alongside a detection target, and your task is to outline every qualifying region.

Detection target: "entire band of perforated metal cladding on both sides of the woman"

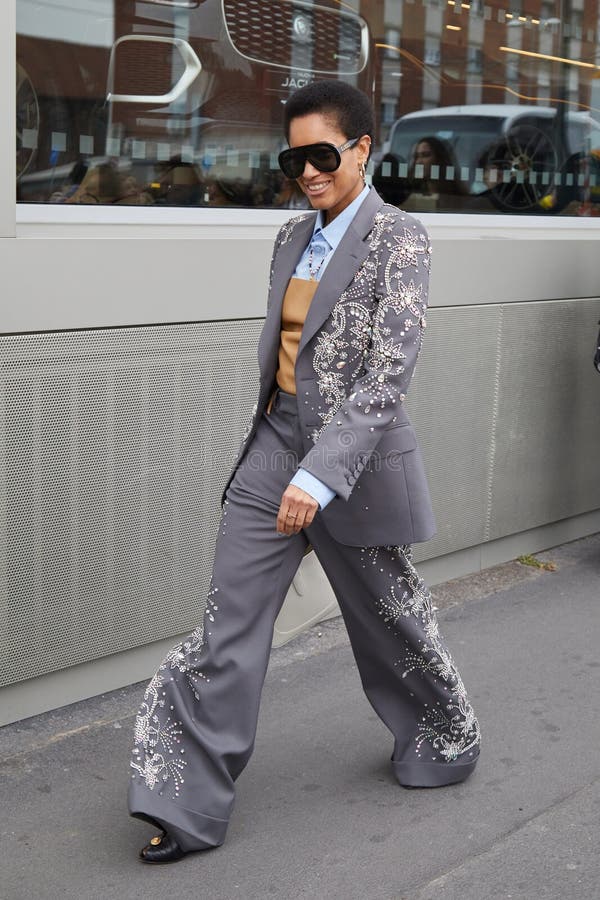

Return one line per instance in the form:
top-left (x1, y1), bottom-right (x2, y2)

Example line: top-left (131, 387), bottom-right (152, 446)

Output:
top-left (0, 300), bottom-right (600, 684)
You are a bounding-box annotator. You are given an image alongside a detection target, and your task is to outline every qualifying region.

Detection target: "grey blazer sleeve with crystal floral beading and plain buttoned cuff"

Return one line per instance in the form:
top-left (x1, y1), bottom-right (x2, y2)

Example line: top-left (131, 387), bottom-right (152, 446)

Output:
top-left (300, 215), bottom-right (431, 500)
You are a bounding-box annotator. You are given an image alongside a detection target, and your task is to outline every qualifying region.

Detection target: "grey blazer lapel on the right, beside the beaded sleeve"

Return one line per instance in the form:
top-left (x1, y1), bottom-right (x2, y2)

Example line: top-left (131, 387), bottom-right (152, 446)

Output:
top-left (292, 188), bottom-right (383, 356)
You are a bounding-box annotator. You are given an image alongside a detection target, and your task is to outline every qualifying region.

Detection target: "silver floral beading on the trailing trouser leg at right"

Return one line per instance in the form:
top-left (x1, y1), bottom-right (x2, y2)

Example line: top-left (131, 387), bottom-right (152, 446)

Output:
top-left (363, 546), bottom-right (481, 762)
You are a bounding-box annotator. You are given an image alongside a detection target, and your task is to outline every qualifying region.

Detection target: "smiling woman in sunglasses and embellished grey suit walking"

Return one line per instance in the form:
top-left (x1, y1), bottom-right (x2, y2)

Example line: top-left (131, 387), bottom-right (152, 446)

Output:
top-left (129, 82), bottom-right (479, 863)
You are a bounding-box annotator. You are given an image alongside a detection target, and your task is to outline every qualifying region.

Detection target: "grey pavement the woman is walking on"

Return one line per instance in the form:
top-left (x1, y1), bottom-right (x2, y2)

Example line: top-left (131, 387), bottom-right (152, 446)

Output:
top-left (0, 535), bottom-right (600, 900)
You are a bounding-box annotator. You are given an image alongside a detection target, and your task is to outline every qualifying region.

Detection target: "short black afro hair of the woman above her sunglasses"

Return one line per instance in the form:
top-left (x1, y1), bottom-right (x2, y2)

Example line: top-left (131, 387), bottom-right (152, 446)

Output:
top-left (284, 81), bottom-right (375, 160)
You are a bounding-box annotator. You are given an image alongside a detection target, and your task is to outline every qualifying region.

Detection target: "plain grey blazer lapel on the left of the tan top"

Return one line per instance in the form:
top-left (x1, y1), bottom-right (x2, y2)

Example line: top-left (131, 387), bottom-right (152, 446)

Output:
top-left (258, 212), bottom-right (315, 380)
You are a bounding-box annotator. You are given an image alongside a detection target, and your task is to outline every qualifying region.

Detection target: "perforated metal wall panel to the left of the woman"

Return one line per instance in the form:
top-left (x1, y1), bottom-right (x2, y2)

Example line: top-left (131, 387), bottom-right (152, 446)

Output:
top-left (0, 321), bottom-right (261, 684)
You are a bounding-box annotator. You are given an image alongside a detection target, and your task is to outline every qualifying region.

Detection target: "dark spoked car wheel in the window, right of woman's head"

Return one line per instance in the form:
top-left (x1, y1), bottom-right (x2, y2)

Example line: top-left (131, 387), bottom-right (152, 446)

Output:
top-left (483, 125), bottom-right (559, 213)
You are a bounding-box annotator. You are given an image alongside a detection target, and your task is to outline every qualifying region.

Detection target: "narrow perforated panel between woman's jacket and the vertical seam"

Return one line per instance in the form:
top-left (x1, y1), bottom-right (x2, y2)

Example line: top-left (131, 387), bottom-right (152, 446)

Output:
top-left (407, 306), bottom-right (501, 559)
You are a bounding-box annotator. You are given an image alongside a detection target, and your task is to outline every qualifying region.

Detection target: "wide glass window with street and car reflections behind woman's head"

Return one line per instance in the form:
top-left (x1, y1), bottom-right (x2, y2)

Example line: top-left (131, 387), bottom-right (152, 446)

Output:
top-left (16, 0), bottom-right (600, 216)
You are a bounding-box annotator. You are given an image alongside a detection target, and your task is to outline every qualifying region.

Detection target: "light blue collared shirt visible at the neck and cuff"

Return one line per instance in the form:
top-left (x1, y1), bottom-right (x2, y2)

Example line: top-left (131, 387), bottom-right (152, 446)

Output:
top-left (290, 185), bottom-right (369, 509)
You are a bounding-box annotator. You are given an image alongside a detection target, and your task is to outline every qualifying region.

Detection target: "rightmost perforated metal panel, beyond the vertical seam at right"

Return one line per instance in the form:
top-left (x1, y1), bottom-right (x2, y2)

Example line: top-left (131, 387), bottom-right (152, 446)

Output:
top-left (485, 300), bottom-right (600, 540)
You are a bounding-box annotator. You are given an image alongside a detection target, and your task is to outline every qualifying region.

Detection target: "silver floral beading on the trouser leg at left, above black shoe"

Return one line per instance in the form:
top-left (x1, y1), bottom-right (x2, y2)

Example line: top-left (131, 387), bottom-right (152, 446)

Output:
top-left (130, 588), bottom-right (219, 799)
